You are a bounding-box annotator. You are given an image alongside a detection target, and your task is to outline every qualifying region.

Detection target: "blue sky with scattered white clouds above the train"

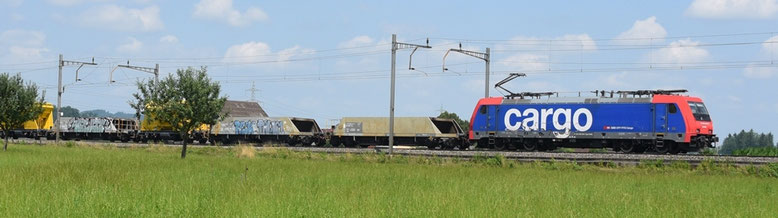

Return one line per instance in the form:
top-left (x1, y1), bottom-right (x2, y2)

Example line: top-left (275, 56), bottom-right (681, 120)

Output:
top-left (0, 0), bottom-right (778, 141)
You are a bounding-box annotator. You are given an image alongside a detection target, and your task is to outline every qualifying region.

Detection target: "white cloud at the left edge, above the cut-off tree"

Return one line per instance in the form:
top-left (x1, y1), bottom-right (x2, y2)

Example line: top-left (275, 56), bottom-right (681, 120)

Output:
top-left (0, 30), bottom-right (49, 60)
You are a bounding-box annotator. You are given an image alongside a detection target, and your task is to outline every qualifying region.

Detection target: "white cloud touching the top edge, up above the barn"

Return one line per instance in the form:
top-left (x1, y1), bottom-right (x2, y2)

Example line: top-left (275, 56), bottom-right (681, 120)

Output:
top-left (194, 0), bottom-right (268, 26)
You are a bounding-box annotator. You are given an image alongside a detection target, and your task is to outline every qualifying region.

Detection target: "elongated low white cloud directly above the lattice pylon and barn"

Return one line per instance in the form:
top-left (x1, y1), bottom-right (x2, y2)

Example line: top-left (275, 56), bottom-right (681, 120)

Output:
top-left (223, 42), bottom-right (316, 64)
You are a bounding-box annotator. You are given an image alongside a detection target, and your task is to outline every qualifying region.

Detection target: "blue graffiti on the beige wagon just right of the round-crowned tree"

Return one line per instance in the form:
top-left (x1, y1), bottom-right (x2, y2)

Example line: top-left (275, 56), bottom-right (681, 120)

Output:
top-left (221, 118), bottom-right (285, 134)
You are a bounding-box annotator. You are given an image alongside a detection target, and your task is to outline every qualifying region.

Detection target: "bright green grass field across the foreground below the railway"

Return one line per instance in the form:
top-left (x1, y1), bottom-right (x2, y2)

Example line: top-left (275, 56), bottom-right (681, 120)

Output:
top-left (0, 142), bottom-right (778, 217)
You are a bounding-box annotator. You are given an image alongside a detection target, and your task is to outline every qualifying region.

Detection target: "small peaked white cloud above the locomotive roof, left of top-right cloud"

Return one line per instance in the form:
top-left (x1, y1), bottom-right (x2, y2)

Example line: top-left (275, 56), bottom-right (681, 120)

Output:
top-left (616, 16), bottom-right (667, 44)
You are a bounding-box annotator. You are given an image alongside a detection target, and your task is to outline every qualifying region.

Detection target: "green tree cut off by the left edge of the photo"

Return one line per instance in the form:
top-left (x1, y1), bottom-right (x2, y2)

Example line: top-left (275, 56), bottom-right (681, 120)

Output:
top-left (0, 73), bottom-right (44, 151)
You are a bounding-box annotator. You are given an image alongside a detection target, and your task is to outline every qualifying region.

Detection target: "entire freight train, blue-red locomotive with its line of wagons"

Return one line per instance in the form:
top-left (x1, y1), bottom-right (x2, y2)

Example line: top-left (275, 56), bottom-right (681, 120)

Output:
top-left (2, 90), bottom-right (718, 154)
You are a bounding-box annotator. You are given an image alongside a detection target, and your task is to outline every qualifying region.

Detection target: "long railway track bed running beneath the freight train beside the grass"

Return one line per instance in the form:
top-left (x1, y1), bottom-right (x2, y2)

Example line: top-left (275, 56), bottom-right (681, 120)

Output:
top-left (12, 140), bottom-right (778, 166)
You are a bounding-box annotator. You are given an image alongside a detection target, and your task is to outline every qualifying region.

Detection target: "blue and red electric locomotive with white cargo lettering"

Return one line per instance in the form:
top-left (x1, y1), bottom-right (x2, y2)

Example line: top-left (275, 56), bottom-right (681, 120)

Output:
top-left (468, 90), bottom-right (718, 154)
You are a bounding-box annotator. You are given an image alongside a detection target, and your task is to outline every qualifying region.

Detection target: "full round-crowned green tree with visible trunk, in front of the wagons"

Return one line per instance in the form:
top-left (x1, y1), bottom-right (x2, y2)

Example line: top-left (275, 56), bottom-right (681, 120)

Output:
top-left (130, 67), bottom-right (227, 158)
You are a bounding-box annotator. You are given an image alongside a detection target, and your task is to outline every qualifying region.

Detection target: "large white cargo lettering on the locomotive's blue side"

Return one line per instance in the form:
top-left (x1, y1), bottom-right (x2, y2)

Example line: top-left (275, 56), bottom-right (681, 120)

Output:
top-left (505, 108), bottom-right (594, 132)
